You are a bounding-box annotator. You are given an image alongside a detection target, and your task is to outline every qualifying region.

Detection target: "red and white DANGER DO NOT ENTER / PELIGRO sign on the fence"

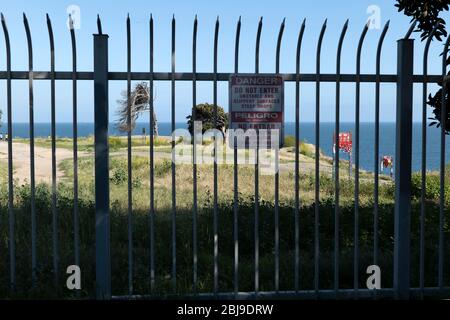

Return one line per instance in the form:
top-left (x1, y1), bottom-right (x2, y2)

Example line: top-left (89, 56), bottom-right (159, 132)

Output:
top-left (229, 74), bottom-right (284, 148)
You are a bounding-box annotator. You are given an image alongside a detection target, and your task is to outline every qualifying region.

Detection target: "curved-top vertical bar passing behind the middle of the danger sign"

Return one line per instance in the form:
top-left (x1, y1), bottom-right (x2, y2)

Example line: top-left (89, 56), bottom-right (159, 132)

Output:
top-left (254, 17), bottom-right (262, 295)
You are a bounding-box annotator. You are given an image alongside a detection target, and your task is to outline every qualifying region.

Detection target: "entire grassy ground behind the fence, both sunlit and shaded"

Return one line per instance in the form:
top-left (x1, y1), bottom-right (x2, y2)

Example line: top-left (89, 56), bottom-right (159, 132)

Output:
top-left (0, 139), bottom-right (450, 298)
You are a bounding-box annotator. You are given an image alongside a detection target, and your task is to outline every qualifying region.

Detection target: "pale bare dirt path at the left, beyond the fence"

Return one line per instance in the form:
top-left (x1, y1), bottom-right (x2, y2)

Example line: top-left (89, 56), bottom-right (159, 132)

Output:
top-left (0, 141), bottom-right (80, 183)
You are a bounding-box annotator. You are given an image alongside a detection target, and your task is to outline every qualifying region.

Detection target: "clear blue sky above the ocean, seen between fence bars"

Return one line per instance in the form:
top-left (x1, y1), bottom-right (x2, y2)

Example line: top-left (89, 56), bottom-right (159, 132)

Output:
top-left (0, 0), bottom-right (449, 122)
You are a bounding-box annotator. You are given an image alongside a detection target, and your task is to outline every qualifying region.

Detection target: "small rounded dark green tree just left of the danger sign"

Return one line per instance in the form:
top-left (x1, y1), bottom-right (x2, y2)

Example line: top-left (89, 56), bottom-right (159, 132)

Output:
top-left (186, 103), bottom-right (228, 138)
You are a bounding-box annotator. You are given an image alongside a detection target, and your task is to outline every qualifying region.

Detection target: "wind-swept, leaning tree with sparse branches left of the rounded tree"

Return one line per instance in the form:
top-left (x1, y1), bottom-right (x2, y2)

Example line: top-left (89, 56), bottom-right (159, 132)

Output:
top-left (116, 82), bottom-right (158, 136)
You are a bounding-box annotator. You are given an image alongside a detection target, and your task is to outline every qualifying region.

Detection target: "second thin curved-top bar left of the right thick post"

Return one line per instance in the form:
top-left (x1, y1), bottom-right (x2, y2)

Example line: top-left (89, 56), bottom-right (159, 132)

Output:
top-left (353, 23), bottom-right (369, 295)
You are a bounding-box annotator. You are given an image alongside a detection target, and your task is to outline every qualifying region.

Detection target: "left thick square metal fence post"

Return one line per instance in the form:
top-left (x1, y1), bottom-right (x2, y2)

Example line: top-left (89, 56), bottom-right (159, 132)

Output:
top-left (94, 34), bottom-right (111, 299)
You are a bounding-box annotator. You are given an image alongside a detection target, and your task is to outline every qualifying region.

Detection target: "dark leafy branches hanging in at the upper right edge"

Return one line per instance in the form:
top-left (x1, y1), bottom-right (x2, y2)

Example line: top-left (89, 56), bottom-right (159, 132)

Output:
top-left (395, 0), bottom-right (450, 134)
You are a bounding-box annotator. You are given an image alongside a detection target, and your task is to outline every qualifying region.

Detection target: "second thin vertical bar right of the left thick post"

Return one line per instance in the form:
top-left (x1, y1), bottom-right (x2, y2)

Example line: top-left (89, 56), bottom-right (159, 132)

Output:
top-left (148, 15), bottom-right (155, 293)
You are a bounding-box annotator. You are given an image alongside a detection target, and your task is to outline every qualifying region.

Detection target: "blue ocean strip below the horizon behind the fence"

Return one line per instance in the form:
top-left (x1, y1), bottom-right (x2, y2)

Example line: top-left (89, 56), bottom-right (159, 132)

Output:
top-left (0, 122), bottom-right (450, 171)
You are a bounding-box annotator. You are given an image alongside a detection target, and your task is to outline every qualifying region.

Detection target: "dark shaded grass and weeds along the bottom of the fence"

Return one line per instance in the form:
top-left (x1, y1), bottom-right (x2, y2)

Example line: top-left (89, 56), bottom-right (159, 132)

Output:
top-left (0, 181), bottom-right (450, 298)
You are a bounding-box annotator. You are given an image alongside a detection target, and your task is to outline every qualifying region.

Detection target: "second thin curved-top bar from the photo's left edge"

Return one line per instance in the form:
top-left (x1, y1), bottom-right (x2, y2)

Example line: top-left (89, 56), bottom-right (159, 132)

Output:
top-left (23, 13), bottom-right (37, 287)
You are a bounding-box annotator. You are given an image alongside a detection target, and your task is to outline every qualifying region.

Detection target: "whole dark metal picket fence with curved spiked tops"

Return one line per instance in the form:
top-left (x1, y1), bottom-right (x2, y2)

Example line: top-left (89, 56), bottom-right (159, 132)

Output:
top-left (0, 14), bottom-right (450, 299)
